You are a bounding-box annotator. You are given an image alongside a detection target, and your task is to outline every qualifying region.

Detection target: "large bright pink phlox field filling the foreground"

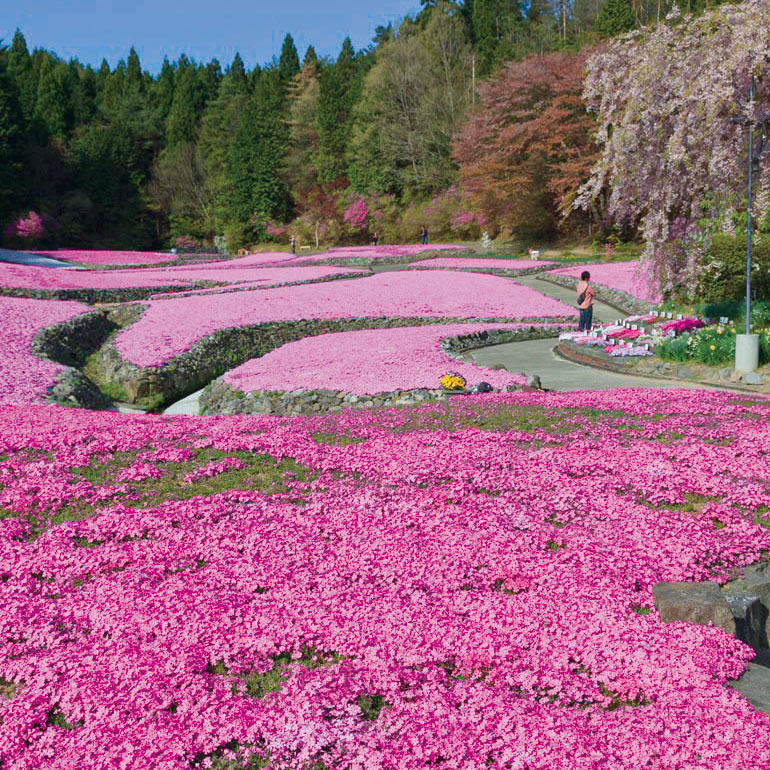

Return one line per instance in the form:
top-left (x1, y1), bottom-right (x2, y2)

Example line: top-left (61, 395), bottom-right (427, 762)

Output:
top-left (0, 390), bottom-right (770, 770)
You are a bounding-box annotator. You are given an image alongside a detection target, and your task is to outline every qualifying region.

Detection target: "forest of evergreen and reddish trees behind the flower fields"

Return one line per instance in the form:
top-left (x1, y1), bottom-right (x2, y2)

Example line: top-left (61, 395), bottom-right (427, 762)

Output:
top-left (0, 0), bottom-right (736, 250)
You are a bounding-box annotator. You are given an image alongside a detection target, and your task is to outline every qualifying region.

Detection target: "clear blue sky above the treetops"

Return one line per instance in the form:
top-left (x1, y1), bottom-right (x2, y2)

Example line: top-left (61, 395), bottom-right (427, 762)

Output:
top-left (0, 0), bottom-right (420, 73)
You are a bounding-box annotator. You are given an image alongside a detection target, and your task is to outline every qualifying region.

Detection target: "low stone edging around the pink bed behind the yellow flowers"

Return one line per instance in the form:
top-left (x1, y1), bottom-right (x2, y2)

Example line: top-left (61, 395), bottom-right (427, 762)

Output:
top-left (200, 325), bottom-right (562, 417)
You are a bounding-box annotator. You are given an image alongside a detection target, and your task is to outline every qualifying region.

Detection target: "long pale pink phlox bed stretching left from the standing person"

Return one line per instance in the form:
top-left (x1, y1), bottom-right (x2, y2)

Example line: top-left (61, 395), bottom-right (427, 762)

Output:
top-left (115, 271), bottom-right (577, 367)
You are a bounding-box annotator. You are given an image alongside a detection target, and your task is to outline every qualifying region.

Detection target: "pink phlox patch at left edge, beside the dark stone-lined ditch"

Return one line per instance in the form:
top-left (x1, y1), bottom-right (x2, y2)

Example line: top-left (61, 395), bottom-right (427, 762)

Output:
top-left (0, 297), bottom-right (89, 402)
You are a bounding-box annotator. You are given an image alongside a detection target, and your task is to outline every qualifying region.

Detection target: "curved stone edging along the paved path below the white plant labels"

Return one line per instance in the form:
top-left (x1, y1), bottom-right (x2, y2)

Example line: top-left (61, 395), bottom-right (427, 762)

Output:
top-left (556, 340), bottom-right (770, 394)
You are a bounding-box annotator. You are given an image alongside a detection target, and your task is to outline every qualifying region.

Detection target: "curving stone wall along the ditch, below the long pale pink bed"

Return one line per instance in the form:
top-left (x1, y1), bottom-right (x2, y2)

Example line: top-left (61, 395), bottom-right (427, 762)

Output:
top-left (41, 305), bottom-right (571, 410)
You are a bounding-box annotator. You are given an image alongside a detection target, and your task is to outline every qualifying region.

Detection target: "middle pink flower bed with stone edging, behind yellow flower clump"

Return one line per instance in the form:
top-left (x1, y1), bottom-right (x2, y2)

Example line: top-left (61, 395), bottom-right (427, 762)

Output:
top-left (201, 324), bottom-right (563, 415)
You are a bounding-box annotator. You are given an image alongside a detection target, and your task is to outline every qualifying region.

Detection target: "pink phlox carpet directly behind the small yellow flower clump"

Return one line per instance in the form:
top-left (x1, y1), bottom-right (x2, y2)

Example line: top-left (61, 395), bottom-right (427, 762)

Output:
top-left (223, 324), bottom-right (552, 395)
